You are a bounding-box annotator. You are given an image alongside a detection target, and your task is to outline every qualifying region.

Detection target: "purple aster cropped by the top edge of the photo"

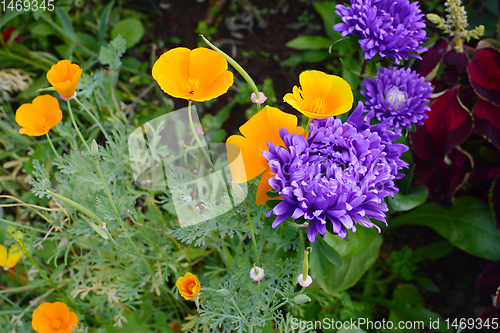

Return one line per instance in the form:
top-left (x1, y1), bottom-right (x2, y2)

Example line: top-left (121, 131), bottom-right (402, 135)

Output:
top-left (333, 0), bottom-right (428, 64)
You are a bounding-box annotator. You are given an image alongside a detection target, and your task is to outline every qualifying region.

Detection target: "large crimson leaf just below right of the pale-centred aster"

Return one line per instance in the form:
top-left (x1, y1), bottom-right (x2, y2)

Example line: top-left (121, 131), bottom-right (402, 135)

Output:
top-left (410, 87), bottom-right (472, 160)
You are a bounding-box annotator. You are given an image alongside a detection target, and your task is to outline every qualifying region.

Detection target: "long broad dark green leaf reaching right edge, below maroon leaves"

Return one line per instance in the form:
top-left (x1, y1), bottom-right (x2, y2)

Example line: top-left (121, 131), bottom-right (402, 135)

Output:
top-left (389, 197), bottom-right (500, 261)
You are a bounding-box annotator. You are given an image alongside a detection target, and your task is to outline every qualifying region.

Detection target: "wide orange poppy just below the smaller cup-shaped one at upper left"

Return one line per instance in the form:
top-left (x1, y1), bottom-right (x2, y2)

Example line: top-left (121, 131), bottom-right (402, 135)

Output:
top-left (16, 95), bottom-right (62, 136)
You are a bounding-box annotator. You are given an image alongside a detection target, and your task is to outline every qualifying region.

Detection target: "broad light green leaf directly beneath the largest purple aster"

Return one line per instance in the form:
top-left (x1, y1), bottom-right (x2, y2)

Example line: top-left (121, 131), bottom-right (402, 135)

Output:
top-left (309, 234), bottom-right (382, 295)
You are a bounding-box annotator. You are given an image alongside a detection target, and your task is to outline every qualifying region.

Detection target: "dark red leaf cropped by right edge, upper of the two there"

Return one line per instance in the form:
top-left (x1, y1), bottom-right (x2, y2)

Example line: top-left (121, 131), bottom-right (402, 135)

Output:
top-left (467, 48), bottom-right (500, 106)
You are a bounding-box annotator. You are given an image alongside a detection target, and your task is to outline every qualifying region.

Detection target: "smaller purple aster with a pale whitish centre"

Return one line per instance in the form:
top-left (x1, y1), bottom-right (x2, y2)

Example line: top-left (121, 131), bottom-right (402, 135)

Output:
top-left (361, 67), bottom-right (432, 132)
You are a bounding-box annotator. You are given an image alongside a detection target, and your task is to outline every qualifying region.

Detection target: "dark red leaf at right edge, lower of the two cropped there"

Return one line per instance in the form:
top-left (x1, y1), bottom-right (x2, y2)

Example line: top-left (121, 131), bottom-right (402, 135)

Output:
top-left (474, 98), bottom-right (500, 147)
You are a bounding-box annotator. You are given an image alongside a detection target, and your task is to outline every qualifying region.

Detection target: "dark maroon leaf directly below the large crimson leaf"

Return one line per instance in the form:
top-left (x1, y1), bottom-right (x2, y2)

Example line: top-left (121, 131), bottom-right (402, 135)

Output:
top-left (414, 149), bottom-right (472, 207)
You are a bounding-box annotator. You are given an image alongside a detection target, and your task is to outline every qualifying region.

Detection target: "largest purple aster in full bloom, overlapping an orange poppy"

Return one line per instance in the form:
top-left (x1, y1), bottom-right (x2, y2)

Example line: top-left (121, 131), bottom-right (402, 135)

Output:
top-left (262, 109), bottom-right (407, 242)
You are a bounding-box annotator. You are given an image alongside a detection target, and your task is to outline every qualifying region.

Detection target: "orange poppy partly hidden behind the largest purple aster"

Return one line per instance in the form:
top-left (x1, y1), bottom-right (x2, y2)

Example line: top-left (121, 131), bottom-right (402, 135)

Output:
top-left (226, 105), bottom-right (306, 205)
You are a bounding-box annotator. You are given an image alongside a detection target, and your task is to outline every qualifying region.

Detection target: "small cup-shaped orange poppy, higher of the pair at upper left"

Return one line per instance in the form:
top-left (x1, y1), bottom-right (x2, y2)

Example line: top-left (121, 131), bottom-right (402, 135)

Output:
top-left (47, 59), bottom-right (82, 101)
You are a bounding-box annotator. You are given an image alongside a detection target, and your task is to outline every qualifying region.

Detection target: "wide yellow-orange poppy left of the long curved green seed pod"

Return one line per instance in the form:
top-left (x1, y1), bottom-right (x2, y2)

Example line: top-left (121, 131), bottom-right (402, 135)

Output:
top-left (152, 47), bottom-right (233, 102)
